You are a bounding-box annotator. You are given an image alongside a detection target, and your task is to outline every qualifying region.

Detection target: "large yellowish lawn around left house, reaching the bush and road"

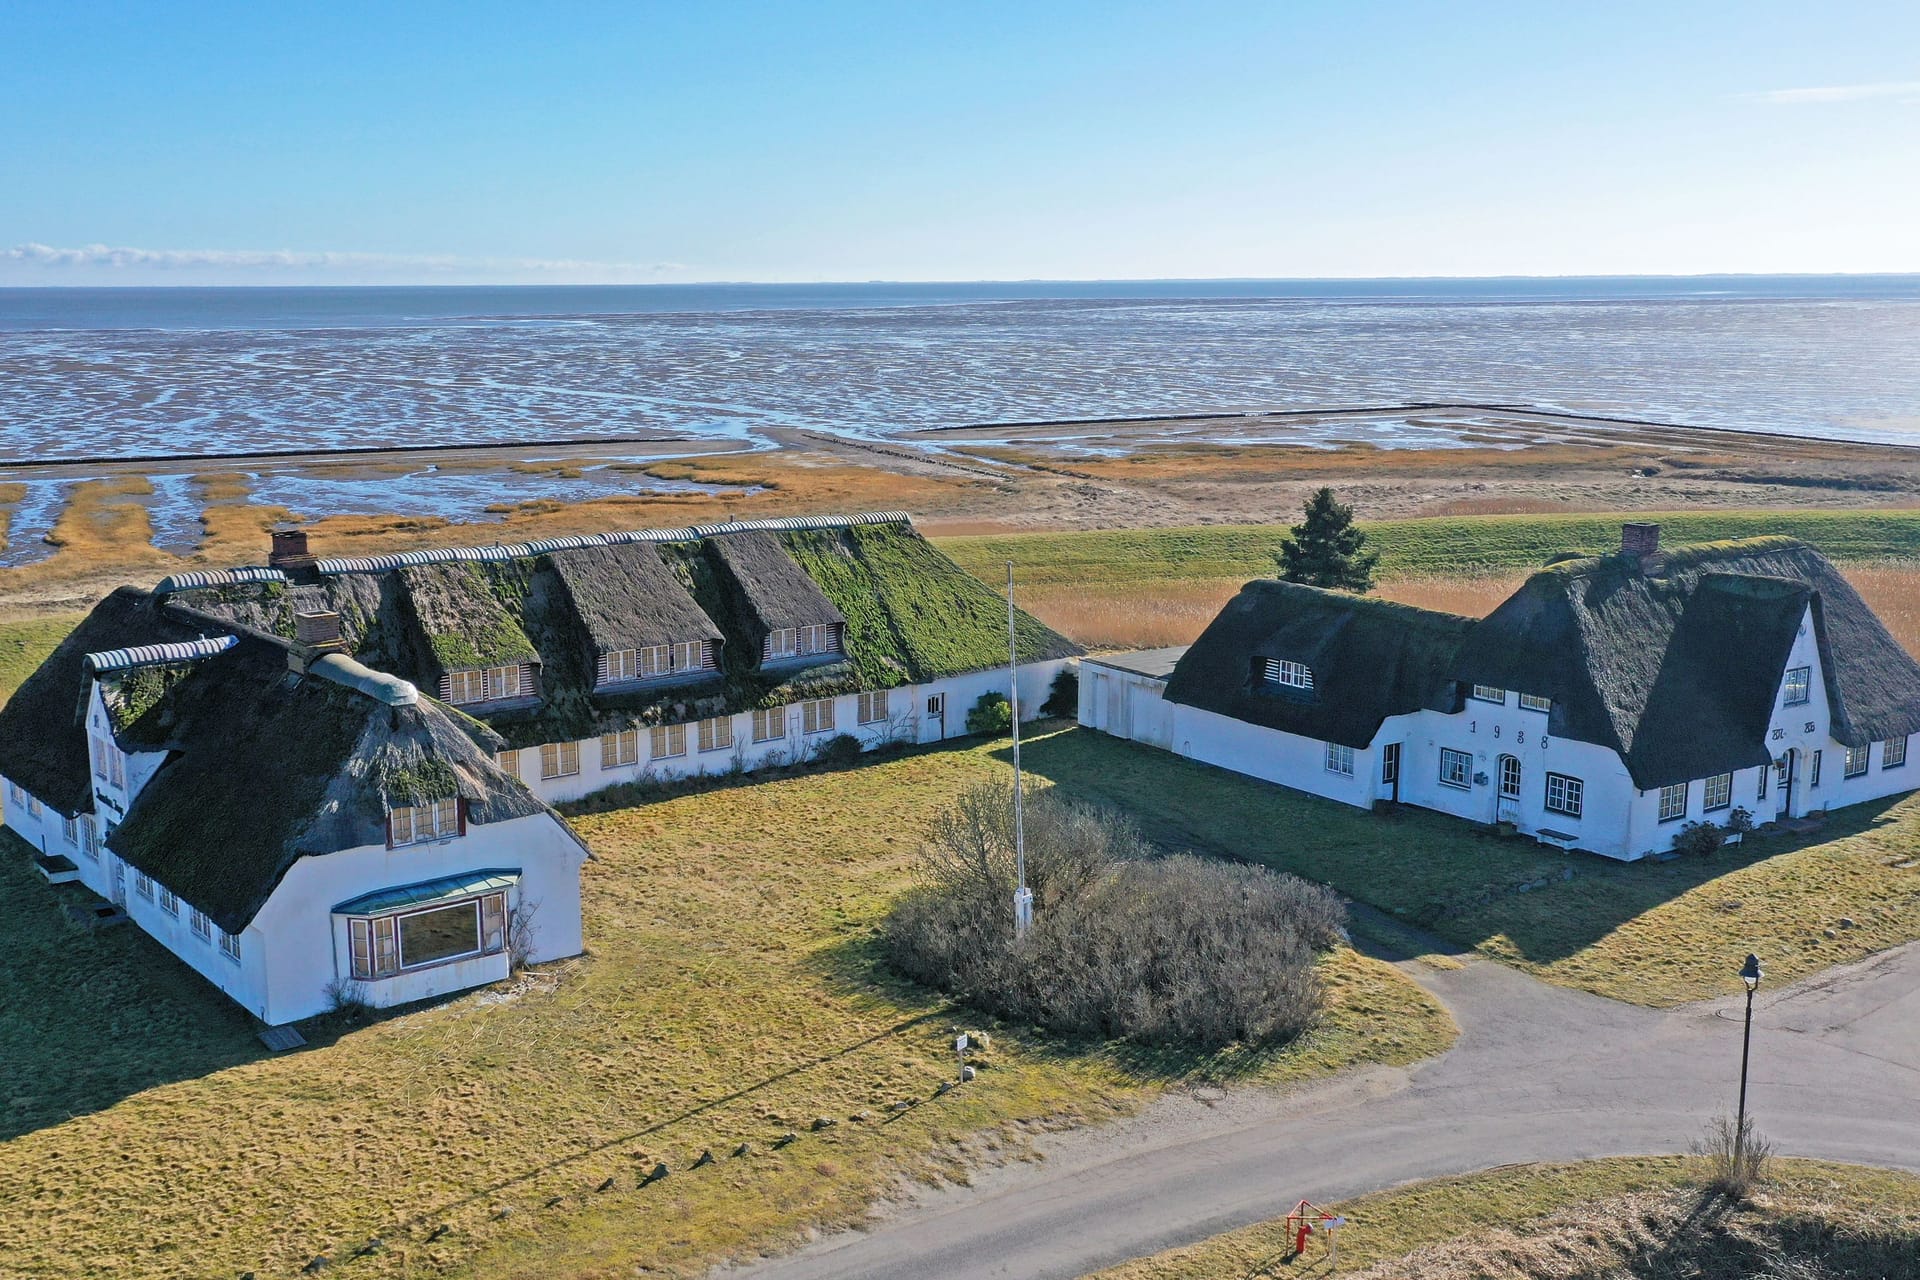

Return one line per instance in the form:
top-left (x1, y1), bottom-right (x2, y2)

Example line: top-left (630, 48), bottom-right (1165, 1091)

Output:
top-left (0, 733), bottom-right (1453, 1280)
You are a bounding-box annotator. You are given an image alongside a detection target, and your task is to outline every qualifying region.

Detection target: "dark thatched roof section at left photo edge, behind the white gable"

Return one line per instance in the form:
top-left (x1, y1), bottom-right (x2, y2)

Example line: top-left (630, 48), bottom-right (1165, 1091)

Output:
top-left (0, 587), bottom-right (200, 818)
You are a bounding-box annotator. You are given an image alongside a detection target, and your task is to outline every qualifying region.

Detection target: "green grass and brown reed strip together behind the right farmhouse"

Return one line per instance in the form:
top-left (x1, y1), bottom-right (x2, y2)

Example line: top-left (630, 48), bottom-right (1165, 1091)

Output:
top-left (937, 510), bottom-right (1920, 649)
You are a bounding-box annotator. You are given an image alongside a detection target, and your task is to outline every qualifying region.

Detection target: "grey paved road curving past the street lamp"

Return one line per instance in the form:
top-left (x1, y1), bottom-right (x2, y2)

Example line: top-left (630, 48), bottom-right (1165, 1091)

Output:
top-left (729, 944), bottom-right (1920, 1280)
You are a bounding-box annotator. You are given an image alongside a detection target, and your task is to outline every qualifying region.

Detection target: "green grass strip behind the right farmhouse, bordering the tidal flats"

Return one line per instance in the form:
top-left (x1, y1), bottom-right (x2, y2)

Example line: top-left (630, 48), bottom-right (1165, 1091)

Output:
top-left (935, 510), bottom-right (1920, 591)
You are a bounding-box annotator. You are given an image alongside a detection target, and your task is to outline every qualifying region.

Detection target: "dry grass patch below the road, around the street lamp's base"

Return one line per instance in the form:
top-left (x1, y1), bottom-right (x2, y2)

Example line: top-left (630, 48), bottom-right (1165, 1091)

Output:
top-left (1089, 1157), bottom-right (1920, 1280)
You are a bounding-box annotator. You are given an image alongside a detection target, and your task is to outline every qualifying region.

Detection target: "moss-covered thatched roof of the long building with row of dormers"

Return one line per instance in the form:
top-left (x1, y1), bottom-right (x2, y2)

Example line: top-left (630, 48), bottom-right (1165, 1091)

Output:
top-left (173, 520), bottom-right (1079, 747)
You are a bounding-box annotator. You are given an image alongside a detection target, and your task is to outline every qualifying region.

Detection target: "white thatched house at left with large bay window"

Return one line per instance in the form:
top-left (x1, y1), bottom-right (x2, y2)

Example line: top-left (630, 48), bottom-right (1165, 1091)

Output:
top-left (0, 587), bottom-right (588, 1025)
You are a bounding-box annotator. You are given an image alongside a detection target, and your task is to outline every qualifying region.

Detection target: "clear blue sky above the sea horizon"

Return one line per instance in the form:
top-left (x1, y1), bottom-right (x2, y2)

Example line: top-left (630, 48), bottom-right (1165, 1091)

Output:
top-left (0, 0), bottom-right (1920, 284)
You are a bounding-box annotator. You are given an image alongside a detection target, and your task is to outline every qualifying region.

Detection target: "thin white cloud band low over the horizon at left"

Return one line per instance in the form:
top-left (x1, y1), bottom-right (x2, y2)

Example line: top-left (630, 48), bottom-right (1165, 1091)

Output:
top-left (0, 244), bottom-right (687, 276)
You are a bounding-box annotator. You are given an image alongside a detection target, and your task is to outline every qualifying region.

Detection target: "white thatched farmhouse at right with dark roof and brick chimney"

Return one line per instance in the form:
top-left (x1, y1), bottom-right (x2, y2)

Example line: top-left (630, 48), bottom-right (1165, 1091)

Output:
top-left (1081, 524), bottom-right (1920, 860)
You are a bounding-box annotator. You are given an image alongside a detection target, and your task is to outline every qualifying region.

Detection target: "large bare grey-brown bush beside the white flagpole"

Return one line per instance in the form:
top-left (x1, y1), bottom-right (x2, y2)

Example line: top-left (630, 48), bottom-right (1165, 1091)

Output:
top-left (885, 785), bottom-right (1346, 1050)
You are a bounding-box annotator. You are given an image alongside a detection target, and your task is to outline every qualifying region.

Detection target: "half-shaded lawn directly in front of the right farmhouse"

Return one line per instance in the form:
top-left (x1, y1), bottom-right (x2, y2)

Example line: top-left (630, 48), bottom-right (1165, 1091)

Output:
top-left (1023, 729), bottom-right (1920, 1006)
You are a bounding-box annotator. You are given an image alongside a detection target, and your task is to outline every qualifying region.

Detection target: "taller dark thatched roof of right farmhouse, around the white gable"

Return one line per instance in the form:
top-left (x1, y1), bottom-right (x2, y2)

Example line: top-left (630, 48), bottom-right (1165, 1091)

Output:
top-left (1452, 537), bottom-right (1920, 789)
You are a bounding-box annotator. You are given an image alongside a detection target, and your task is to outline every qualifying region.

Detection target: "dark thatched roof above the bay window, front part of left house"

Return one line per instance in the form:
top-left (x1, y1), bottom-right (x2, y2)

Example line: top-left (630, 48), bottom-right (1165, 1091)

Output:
top-left (108, 639), bottom-right (545, 933)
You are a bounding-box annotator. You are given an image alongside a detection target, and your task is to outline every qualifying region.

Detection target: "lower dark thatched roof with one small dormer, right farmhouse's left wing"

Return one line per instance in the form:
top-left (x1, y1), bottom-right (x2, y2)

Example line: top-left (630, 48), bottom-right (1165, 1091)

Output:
top-left (1165, 580), bottom-right (1473, 747)
